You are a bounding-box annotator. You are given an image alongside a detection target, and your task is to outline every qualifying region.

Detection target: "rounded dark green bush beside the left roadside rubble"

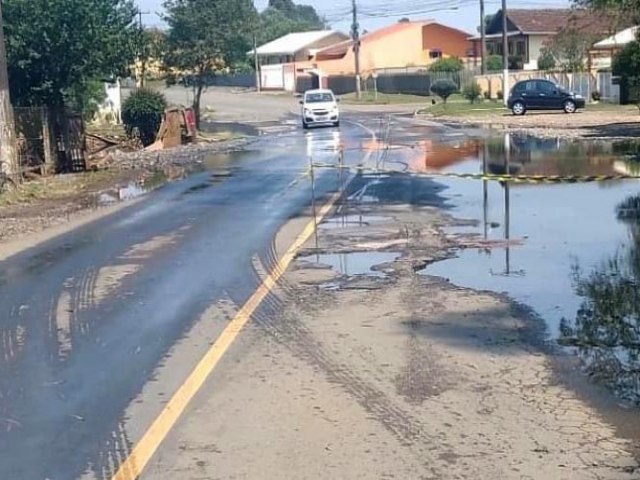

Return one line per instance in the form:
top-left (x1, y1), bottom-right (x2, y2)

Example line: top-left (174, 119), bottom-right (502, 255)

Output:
top-left (122, 88), bottom-right (167, 147)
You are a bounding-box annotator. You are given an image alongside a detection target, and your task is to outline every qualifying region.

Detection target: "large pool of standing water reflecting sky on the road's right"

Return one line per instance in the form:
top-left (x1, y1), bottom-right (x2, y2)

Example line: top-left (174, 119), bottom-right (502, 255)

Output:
top-left (418, 135), bottom-right (640, 402)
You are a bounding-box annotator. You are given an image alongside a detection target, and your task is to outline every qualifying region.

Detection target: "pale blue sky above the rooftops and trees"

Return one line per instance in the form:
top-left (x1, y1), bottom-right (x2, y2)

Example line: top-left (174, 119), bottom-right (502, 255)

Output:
top-left (136, 0), bottom-right (570, 33)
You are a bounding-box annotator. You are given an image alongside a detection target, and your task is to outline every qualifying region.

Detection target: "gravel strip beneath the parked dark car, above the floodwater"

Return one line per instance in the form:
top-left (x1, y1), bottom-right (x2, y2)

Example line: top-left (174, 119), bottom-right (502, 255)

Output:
top-left (419, 108), bottom-right (640, 139)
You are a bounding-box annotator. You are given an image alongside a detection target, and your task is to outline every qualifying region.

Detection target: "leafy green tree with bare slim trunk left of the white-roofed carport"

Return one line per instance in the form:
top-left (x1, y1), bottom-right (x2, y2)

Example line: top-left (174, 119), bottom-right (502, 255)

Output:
top-left (164, 0), bottom-right (256, 127)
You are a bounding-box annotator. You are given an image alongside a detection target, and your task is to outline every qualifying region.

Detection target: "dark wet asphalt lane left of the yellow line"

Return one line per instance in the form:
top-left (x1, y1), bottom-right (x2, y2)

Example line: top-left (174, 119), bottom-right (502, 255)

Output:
top-left (0, 117), bottom-right (382, 480)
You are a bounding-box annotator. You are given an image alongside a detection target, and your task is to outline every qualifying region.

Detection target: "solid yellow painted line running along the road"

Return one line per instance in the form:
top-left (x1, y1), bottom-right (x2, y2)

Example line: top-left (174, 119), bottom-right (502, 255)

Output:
top-left (112, 188), bottom-right (342, 480)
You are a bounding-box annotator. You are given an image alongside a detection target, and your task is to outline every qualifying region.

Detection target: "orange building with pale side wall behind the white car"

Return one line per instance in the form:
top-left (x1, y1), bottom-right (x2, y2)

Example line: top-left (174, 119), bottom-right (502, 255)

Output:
top-left (308, 21), bottom-right (473, 75)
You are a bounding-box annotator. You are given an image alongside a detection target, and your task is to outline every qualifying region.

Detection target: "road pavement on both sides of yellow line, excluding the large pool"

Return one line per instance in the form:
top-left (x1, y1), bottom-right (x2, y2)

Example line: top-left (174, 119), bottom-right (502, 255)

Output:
top-left (0, 89), bottom-right (640, 480)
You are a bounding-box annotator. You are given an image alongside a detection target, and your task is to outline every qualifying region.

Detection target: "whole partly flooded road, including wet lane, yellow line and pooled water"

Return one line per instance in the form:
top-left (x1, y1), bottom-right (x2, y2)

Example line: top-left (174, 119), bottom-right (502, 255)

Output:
top-left (0, 108), bottom-right (640, 480)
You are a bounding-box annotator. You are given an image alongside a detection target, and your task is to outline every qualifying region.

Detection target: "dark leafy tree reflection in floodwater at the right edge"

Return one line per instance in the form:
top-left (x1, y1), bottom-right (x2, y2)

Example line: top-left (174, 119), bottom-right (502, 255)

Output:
top-left (560, 195), bottom-right (640, 404)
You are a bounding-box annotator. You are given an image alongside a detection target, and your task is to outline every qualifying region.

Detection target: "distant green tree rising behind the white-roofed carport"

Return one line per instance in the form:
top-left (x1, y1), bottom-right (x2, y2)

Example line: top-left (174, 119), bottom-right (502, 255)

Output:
top-left (258, 0), bottom-right (327, 44)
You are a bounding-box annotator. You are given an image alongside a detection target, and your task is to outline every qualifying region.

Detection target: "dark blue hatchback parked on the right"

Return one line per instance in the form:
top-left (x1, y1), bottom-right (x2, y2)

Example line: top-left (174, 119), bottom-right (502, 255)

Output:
top-left (507, 79), bottom-right (585, 115)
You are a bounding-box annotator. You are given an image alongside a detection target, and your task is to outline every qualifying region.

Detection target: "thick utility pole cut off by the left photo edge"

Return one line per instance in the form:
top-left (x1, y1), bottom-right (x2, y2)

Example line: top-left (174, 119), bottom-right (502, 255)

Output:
top-left (0, 2), bottom-right (20, 181)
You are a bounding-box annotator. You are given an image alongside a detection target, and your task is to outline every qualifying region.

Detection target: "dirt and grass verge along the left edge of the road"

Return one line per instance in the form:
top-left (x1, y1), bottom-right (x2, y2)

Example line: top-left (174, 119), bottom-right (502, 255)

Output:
top-left (0, 138), bottom-right (252, 253)
